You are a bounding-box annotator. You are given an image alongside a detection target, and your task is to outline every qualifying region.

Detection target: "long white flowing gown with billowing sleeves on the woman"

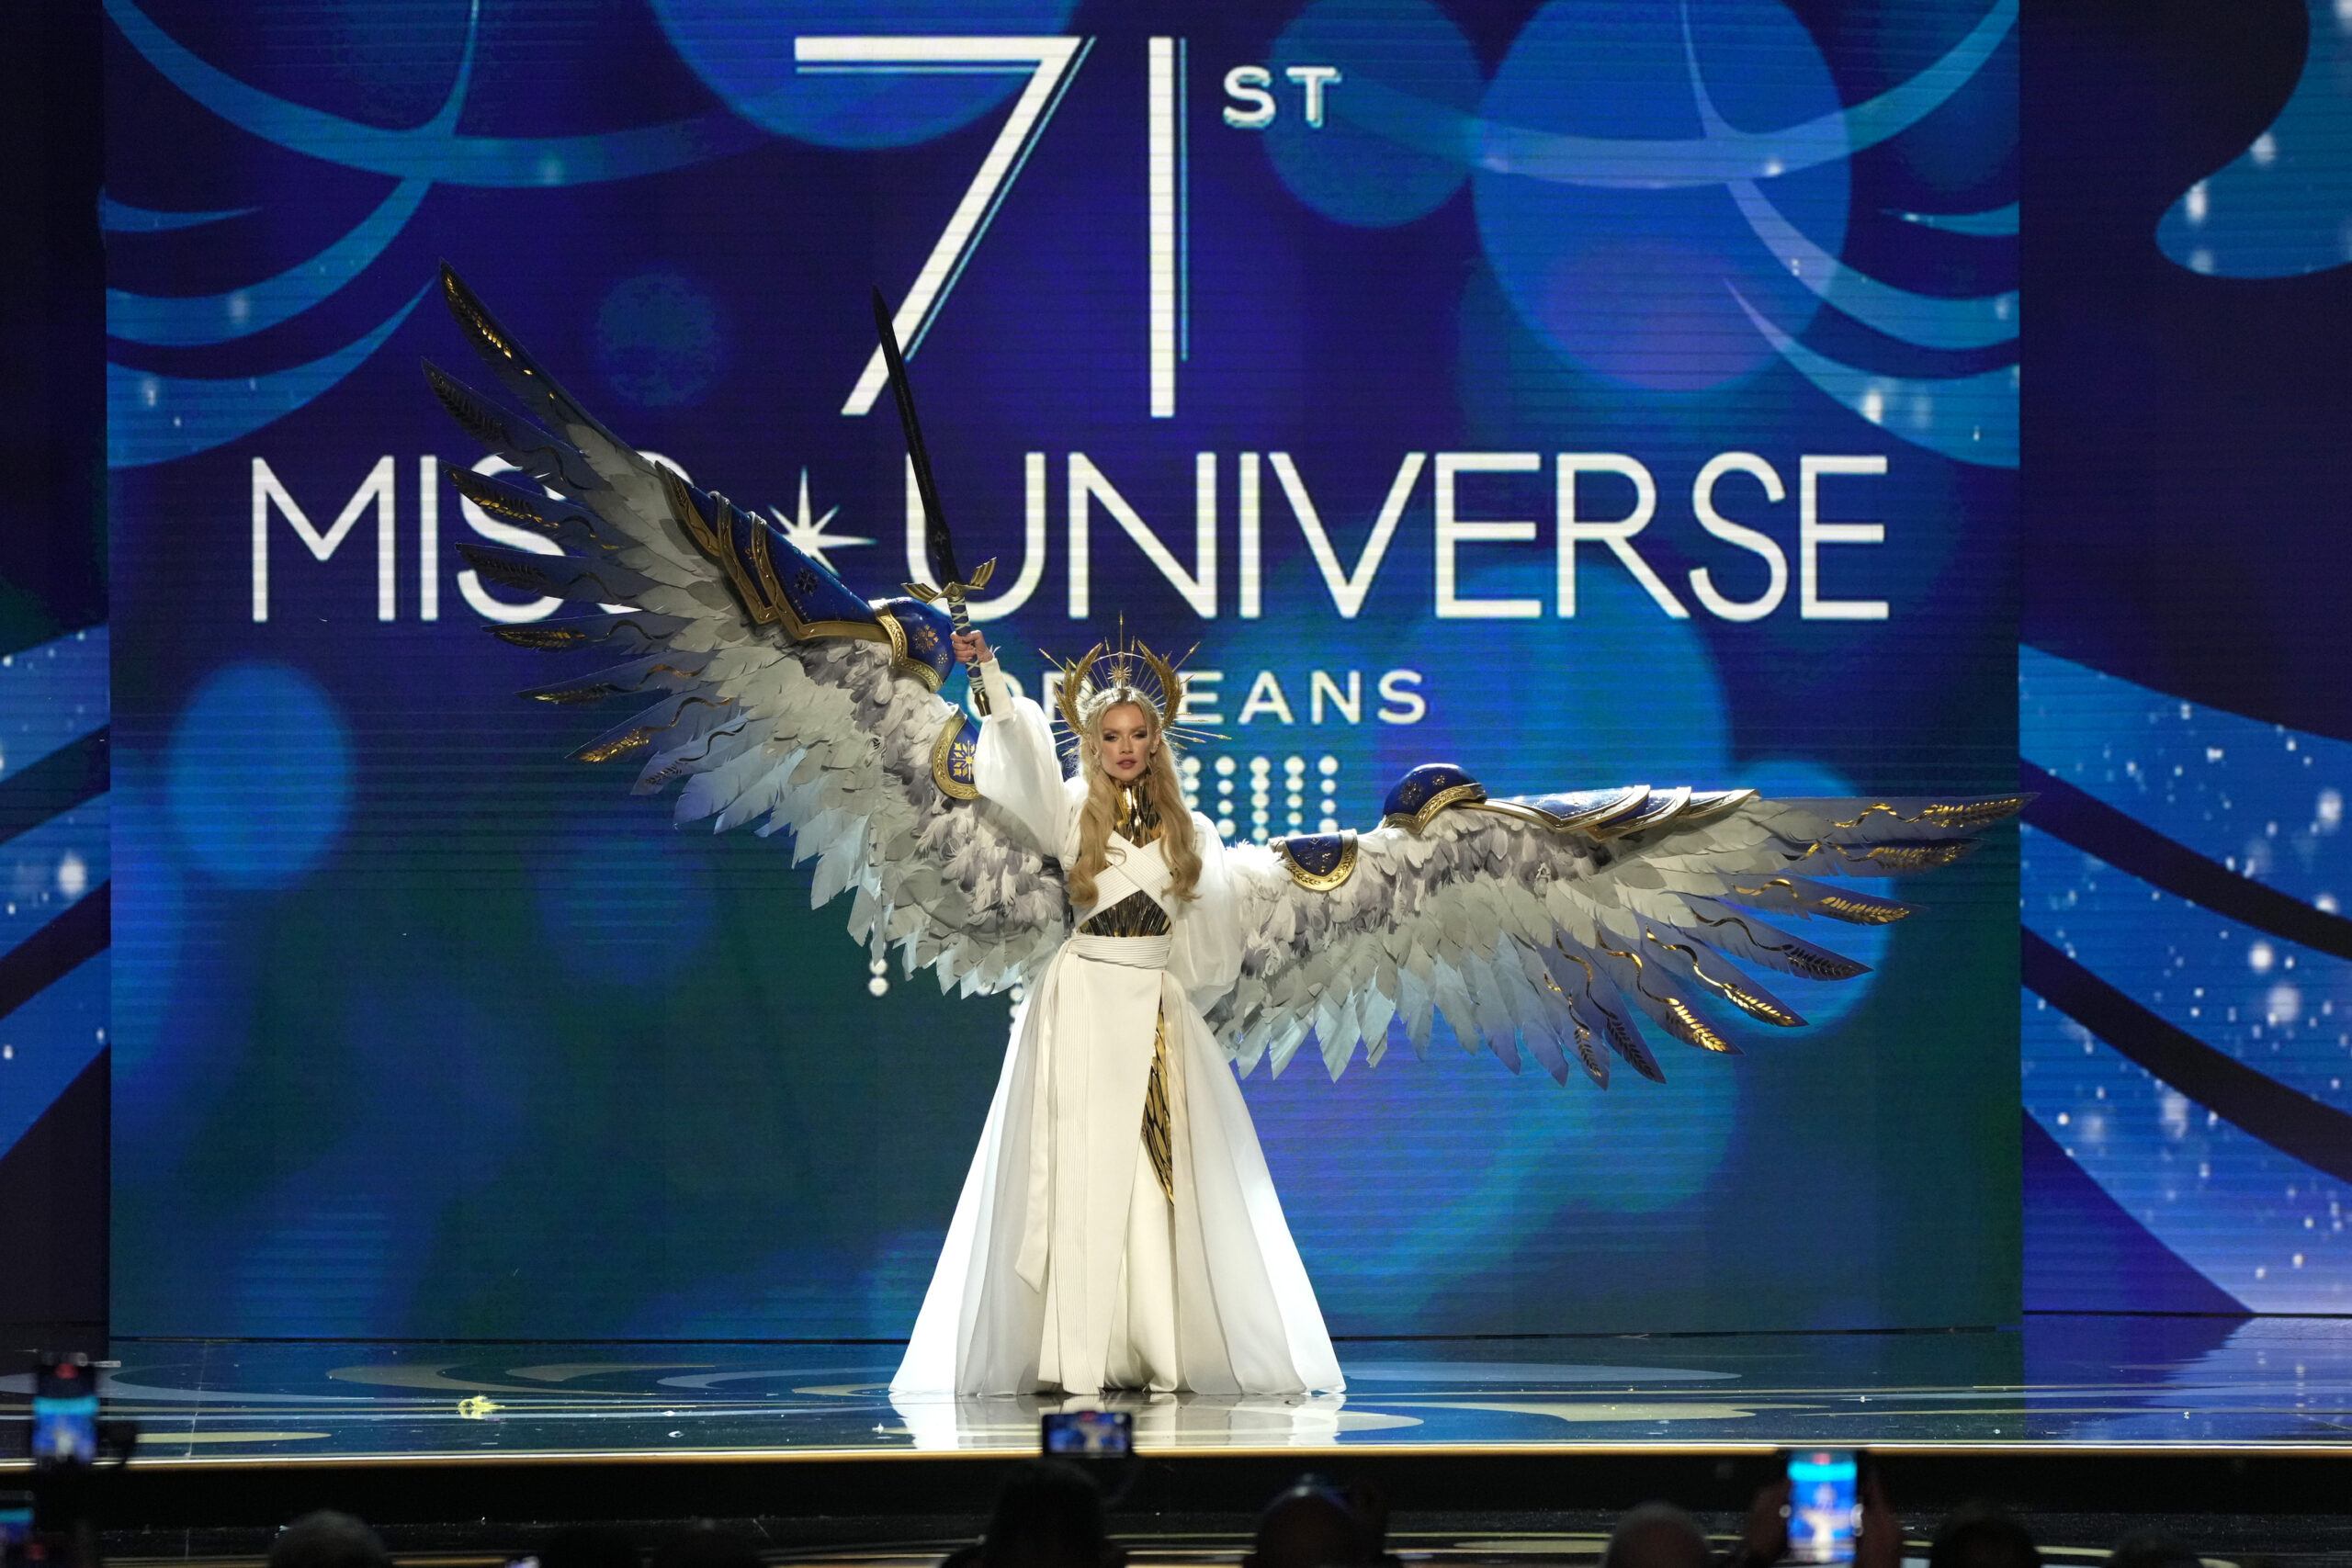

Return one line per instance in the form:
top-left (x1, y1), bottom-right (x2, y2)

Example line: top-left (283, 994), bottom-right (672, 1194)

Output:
top-left (891, 663), bottom-right (1343, 1394)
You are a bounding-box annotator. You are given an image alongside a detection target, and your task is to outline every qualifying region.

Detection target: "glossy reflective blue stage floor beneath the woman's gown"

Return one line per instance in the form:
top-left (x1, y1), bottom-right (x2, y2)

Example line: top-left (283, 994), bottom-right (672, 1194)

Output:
top-left (22, 1316), bottom-right (2352, 1464)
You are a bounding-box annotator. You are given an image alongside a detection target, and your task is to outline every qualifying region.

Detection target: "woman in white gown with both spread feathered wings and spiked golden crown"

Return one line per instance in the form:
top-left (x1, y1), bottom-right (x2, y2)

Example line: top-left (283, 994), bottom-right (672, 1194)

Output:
top-left (425, 268), bottom-right (2025, 1416)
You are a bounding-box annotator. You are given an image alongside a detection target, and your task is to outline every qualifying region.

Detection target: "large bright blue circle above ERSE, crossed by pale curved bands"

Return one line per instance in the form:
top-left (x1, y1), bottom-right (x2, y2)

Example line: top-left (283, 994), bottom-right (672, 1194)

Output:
top-left (1473, 0), bottom-right (1847, 392)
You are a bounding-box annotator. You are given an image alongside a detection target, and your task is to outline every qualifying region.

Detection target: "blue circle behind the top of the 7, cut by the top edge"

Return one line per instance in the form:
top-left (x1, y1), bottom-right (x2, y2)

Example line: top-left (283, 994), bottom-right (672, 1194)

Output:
top-left (654, 0), bottom-right (1072, 148)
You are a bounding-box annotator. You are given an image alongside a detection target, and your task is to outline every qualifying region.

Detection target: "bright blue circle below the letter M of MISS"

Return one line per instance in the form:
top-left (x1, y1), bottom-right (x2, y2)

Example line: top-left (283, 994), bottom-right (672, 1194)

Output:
top-left (164, 663), bottom-right (350, 888)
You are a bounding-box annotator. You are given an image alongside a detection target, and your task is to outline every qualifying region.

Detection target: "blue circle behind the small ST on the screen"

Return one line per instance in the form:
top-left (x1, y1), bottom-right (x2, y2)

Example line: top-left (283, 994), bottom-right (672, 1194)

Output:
top-left (1265, 0), bottom-right (1487, 228)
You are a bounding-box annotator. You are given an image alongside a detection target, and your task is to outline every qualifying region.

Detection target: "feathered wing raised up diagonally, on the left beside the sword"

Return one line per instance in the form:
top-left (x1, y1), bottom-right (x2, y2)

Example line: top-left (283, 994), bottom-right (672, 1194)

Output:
top-left (425, 257), bottom-right (1063, 992)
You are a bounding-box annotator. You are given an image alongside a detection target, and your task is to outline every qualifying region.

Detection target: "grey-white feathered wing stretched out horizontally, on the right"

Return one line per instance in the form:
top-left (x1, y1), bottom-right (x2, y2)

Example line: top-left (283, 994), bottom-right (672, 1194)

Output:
top-left (1211, 784), bottom-right (2023, 1086)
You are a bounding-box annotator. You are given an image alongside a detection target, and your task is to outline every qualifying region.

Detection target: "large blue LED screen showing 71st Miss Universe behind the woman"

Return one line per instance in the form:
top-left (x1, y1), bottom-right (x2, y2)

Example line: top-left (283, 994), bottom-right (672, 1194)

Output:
top-left (106, 0), bottom-right (2018, 1337)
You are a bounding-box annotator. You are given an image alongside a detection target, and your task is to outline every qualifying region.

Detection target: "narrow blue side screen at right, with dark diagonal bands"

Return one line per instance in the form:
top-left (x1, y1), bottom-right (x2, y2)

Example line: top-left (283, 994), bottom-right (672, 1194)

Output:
top-left (2018, 0), bottom-right (2352, 1314)
